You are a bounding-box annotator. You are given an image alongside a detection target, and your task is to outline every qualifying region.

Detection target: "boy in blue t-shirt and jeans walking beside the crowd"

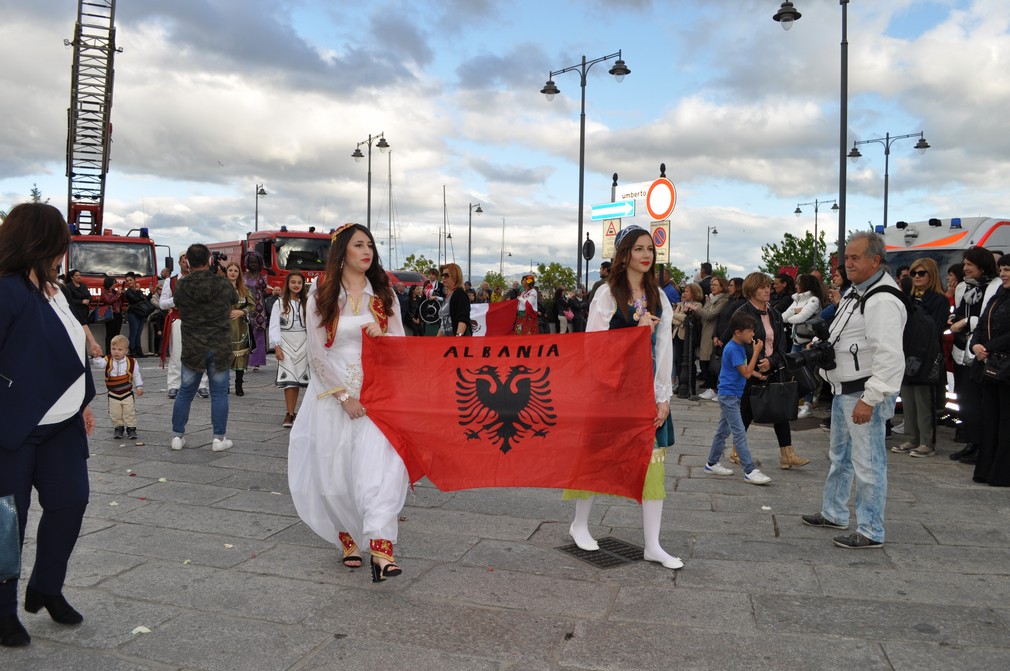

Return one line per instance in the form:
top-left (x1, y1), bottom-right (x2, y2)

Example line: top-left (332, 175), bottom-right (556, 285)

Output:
top-left (705, 311), bottom-right (772, 485)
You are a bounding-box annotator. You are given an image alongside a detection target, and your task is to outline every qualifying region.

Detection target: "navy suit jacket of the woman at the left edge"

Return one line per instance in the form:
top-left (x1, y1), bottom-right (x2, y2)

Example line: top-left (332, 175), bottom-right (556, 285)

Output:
top-left (0, 275), bottom-right (95, 450)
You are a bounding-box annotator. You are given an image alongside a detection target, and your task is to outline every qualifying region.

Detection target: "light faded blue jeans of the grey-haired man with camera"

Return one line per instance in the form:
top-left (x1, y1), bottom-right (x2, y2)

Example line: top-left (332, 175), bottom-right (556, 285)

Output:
top-left (821, 392), bottom-right (897, 543)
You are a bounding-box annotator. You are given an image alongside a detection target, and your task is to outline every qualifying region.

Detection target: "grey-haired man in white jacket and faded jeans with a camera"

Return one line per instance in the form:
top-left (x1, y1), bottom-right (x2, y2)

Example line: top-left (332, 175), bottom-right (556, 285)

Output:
top-left (803, 231), bottom-right (907, 549)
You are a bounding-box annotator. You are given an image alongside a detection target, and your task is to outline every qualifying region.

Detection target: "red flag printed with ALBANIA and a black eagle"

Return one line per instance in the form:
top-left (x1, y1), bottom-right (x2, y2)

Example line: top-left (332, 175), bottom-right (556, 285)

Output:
top-left (361, 328), bottom-right (655, 501)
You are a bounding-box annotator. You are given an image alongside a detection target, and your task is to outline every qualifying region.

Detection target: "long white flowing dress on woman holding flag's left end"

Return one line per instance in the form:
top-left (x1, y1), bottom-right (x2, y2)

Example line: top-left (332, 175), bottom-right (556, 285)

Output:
top-left (288, 284), bottom-right (410, 548)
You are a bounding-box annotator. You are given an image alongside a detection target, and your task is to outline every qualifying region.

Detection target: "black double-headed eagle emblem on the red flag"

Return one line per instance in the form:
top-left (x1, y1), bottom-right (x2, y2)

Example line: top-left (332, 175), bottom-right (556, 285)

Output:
top-left (456, 365), bottom-right (558, 454)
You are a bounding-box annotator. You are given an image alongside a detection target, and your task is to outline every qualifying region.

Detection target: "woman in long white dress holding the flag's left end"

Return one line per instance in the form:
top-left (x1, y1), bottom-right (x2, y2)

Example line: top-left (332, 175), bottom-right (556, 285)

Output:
top-left (286, 223), bottom-right (408, 582)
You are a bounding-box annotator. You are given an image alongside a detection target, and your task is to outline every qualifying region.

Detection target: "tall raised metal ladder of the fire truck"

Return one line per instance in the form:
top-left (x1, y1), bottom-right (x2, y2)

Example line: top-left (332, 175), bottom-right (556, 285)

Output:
top-left (64, 0), bottom-right (122, 235)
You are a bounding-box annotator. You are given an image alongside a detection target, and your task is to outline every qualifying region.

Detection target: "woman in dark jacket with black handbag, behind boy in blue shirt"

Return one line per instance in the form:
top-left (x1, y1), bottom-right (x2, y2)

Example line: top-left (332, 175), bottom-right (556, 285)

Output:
top-left (723, 273), bottom-right (810, 469)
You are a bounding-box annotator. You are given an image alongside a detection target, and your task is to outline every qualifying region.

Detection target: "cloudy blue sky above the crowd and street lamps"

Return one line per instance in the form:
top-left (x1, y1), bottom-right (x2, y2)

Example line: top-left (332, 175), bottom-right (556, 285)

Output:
top-left (0, 0), bottom-right (1010, 278)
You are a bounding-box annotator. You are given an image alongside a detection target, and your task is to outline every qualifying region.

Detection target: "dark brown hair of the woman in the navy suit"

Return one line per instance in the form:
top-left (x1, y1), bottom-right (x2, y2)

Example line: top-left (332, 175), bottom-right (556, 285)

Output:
top-left (0, 203), bottom-right (70, 300)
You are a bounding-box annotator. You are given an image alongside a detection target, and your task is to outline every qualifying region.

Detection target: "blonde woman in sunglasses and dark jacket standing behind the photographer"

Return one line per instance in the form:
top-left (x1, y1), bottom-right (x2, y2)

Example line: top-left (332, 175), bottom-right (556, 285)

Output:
top-left (891, 257), bottom-right (950, 457)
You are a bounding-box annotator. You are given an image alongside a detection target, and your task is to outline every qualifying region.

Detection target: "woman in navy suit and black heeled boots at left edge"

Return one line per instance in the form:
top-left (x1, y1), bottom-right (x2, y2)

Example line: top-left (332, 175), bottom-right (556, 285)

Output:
top-left (0, 203), bottom-right (98, 646)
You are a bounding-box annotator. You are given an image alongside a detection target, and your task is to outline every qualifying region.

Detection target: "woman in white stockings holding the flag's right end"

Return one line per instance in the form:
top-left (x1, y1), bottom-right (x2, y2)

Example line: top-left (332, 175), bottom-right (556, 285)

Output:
top-left (565, 225), bottom-right (684, 569)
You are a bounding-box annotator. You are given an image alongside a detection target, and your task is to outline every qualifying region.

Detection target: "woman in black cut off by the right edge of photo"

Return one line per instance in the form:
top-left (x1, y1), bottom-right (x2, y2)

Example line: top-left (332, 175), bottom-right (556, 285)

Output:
top-left (971, 255), bottom-right (1010, 487)
